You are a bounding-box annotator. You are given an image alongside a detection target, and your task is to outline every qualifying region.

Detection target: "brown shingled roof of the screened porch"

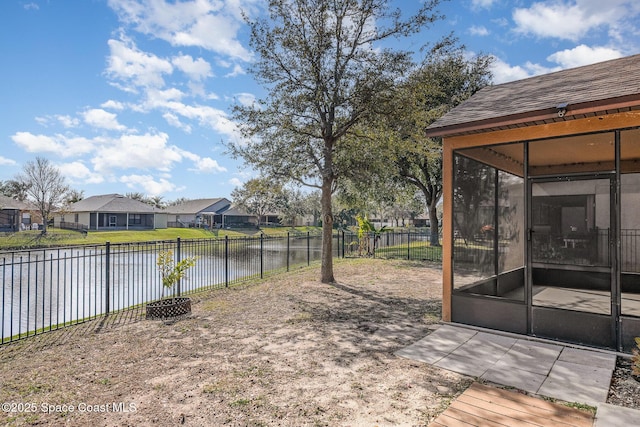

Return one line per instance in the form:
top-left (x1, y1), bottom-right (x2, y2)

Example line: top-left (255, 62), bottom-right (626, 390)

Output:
top-left (427, 55), bottom-right (640, 136)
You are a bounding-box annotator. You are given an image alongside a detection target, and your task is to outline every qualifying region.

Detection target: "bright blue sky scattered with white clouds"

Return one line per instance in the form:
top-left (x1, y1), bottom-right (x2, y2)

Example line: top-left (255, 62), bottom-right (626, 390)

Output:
top-left (0, 0), bottom-right (640, 201)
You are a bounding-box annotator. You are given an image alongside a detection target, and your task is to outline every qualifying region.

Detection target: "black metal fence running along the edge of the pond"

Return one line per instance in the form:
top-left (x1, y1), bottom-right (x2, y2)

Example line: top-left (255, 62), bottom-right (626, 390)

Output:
top-left (0, 232), bottom-right (441, 344)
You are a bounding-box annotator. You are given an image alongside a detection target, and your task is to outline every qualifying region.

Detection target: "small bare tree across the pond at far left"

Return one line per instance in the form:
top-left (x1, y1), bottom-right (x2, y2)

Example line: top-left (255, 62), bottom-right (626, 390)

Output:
top-left (16, 157), bottom-right (69, 234)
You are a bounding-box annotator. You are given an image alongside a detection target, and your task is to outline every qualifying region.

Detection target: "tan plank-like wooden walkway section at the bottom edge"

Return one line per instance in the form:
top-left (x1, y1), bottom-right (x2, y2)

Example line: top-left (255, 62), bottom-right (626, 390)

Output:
top-left (429, 383), bottom-right (594, 427)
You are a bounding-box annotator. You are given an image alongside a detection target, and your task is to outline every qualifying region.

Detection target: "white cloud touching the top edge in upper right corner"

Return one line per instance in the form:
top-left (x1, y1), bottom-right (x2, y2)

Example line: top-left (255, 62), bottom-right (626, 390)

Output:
top-left (513, 0), bottom-right (640, 41)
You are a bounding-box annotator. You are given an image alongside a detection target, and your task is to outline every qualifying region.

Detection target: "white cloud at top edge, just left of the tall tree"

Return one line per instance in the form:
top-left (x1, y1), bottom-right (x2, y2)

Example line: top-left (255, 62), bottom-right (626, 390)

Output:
top-left (108, 0), bottom-right (258, 61)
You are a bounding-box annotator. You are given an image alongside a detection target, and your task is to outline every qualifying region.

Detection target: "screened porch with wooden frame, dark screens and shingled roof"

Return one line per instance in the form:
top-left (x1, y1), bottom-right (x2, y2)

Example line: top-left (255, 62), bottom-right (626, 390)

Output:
top-left (428, 56), bottom-right (640, 351)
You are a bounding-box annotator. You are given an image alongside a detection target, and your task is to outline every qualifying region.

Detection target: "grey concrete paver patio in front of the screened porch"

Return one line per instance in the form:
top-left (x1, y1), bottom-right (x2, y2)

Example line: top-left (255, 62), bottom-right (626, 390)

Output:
top-left (396, 325), bottom-right (616, 406)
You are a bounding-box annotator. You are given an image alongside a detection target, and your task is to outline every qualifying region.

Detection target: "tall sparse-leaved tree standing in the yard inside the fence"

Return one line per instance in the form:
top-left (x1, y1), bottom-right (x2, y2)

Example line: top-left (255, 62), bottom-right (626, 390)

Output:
top-left (231, 0), bottom-right (440, 283)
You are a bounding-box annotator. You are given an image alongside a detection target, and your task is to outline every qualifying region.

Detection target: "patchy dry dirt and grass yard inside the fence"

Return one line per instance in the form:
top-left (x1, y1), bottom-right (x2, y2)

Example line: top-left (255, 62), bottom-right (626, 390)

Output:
top-left (0, 260), bottom-right (471, 426)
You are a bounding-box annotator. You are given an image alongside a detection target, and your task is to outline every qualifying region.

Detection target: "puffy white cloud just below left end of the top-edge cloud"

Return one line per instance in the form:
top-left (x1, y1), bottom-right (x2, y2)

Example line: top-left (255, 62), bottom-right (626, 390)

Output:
top-left (106, 39), bottom-right (173, 93)
